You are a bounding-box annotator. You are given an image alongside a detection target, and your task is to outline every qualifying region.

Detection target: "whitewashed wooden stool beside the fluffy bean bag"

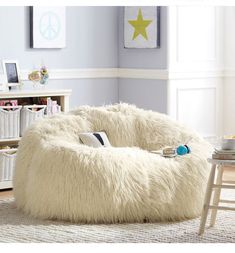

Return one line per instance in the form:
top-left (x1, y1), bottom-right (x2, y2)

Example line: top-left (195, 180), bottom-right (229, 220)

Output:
top-left (199, 159), bottom-right (235, 235)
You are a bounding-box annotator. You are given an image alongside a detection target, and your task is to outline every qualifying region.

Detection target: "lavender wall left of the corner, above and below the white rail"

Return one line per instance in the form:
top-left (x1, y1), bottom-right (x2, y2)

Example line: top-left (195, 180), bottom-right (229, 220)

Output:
top-left (0, 7), bottom-right (118, 108)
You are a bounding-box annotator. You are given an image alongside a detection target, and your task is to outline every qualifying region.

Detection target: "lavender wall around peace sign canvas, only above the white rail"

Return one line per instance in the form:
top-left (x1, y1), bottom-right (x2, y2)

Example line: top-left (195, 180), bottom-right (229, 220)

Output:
top-left (0, 7), bottom-right (118, 69)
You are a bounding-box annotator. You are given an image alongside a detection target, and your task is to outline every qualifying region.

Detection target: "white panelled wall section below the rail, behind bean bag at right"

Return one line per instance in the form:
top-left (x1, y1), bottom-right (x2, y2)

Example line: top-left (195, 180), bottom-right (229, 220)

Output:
top-left (168, 78), bottom-right (223, 136)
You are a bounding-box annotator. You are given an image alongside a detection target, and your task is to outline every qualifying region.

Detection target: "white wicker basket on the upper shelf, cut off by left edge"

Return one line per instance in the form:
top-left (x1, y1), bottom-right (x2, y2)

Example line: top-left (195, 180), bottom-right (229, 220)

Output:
top-left (0, 105), bottom-right (22, 139)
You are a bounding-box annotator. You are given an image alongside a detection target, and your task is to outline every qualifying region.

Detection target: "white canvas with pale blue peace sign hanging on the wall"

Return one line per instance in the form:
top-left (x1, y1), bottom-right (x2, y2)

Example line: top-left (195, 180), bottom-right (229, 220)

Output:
top-left (30, 6), bottom-right (66, 48)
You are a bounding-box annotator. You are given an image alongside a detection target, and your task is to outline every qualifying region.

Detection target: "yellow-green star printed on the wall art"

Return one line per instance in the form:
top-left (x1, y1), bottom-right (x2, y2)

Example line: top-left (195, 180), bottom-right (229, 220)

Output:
top-left (128, 9), bottom-right (153, 40)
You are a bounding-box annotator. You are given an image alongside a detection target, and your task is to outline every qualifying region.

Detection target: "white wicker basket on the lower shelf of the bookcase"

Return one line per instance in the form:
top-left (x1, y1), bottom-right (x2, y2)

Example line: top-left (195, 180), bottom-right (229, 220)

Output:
top-left (0, 148), bottom-right (17, 182)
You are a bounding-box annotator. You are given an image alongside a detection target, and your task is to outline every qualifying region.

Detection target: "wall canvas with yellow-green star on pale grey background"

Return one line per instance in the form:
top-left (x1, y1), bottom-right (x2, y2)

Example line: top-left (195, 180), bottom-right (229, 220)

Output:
top-left (124, 6), bottom-right (160, 48)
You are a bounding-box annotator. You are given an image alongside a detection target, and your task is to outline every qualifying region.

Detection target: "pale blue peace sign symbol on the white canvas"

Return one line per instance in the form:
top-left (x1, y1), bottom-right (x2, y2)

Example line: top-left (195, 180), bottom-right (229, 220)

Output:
top-left (39, 12), bottom-right (60, 40)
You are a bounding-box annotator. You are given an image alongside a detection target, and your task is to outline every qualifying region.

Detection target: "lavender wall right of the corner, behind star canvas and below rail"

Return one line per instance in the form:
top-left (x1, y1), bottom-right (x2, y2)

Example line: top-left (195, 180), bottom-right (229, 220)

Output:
top-left (118, 7), bottom-right (167, 113)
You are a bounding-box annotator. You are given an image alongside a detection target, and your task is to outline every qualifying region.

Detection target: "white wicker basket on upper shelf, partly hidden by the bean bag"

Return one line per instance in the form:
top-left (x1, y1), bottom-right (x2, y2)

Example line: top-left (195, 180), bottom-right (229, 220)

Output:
top-left (20, 105), bottom-right (46, 136)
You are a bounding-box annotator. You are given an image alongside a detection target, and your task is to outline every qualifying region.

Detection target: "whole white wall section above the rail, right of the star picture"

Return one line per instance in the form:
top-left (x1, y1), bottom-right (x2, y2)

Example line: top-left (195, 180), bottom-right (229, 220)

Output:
top-left (168, 6), bottom-right (223, 72)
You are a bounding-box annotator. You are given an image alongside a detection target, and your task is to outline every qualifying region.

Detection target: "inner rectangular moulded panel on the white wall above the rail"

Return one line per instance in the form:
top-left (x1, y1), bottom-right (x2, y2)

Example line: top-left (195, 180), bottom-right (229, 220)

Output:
top-left (176, 6), bottom-right (216, 62)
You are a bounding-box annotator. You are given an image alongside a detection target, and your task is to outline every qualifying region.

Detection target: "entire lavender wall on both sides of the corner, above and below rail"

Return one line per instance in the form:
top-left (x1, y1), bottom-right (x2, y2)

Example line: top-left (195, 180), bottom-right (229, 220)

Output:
top-left (0, 7), bottom-right (167, 112)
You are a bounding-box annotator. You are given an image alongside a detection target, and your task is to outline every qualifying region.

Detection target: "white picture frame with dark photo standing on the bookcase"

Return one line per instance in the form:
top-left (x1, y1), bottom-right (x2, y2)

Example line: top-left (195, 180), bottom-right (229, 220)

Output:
top-left (2, 60), bottom-right (20, 87)
